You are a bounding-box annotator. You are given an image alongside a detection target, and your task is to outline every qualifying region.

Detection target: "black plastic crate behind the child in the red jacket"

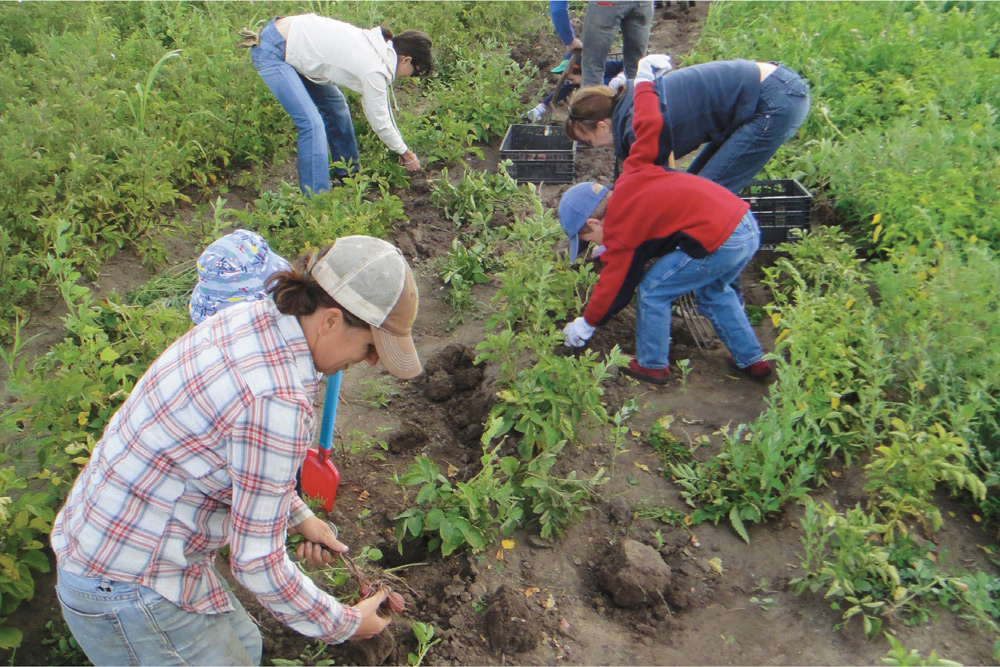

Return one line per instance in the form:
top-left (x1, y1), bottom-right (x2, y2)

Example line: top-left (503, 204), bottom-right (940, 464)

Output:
top-left (740, 178), bottom-right (812, 250)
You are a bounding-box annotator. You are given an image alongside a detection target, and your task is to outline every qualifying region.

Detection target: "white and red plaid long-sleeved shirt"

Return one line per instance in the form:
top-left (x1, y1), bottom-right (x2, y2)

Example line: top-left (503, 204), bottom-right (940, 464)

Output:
top-left (52, 299), bottom-right (361, 643)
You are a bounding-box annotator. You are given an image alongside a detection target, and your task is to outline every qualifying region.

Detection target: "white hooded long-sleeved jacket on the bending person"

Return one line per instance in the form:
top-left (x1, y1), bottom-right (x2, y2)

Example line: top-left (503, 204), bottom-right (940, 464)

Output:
top-left (285, 14), bottom-right (407, 155)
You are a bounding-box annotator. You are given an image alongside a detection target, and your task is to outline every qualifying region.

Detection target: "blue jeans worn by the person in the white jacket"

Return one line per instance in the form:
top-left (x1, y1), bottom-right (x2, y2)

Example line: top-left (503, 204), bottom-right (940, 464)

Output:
top-left (250, 21), bottom-right (359, 195)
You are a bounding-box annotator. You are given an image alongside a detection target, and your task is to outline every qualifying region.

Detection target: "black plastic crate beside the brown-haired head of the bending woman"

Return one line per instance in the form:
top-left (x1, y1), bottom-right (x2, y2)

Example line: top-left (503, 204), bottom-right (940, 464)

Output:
top-left (500, 125), bottom-right (576, 183)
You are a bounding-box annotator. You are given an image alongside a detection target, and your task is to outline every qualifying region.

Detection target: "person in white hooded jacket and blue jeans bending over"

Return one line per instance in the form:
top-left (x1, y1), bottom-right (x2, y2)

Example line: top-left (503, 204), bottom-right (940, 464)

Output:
top-left (250, 14), bottom-right (433, 195)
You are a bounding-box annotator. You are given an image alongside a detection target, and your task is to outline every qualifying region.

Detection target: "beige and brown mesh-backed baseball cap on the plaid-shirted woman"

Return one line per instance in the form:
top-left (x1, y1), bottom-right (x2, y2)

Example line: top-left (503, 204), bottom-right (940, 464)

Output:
top-left (311, 236), bottom-right (423, 380)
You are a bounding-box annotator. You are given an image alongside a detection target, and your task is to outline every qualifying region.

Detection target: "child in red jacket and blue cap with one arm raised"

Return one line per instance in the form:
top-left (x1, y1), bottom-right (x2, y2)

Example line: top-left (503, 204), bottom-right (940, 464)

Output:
top-left (559, 56), bottom-right (771, 384)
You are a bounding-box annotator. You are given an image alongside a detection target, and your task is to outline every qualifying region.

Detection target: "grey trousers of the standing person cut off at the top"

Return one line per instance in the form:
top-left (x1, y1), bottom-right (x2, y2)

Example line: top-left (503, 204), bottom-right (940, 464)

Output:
top-left (580, 0), bottom-right (653, 86)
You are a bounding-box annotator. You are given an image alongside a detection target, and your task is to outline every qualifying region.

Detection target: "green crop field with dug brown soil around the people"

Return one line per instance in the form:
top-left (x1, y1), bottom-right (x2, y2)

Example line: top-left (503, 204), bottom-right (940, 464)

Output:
top-left (0, 2), bottom-right (1000, 665)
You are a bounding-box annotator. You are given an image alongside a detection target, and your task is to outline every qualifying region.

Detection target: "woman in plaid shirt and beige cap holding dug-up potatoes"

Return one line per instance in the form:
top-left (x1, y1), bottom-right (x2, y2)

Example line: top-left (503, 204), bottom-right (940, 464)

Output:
top-left (51, 236), bottom-right (421, 665)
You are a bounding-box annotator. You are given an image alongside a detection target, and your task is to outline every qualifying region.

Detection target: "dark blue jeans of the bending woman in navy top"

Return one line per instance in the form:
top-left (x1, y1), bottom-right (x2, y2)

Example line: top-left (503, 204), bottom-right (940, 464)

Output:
top-left (678, 65), bottom-right (809, 194)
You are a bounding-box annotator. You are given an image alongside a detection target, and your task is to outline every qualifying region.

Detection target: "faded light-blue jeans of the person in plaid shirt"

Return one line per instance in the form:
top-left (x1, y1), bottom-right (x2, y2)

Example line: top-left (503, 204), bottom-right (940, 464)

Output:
top-left (56, 568), bottom-right (261, 665)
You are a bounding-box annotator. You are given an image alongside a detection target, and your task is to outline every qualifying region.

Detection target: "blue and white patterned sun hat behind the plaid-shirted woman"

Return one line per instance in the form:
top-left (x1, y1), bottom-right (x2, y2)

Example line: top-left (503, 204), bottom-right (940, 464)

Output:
top-left (188, 229), bottom-right (291, 324)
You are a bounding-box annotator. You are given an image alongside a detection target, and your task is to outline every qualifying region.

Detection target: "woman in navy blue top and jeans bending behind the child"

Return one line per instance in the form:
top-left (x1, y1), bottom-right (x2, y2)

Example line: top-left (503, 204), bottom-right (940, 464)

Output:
top-left (566, 60), bottom-right (809, 194)
